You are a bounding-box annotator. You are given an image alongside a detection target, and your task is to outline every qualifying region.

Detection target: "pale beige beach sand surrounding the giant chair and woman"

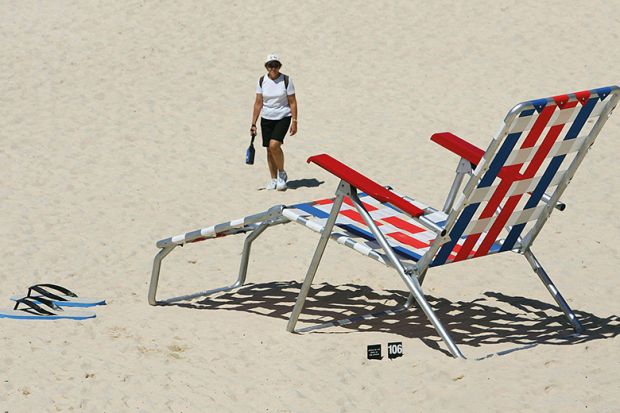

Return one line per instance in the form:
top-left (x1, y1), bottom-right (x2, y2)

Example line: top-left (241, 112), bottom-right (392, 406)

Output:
top-left (0, 0), bottom-right (620, 413)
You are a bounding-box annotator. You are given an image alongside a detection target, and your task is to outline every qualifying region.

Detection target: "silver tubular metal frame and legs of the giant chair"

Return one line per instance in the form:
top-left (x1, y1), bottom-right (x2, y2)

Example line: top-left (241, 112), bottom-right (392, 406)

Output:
top-left (148, 87), bottom-right (620, 358)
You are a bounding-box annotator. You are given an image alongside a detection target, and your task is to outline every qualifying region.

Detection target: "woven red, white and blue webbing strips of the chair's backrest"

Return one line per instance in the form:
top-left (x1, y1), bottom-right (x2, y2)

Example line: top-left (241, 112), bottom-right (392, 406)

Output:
top-left (432, 90), bottom-right (609, 265)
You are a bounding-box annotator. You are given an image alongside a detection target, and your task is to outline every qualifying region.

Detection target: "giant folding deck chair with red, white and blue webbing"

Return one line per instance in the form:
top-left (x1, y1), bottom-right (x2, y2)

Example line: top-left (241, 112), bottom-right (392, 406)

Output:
top-left (148, 86), bottom-right (620, 357)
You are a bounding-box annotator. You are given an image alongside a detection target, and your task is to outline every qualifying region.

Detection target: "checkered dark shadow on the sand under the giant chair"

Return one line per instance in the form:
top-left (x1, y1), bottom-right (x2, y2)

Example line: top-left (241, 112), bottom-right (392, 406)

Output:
top-left (170, 281), bottom-right (620, 356)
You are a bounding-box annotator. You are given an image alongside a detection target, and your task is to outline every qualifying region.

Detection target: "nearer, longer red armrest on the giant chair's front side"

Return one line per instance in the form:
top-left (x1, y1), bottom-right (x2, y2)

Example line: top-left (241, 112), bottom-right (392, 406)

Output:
top-left (307, 154), bottom-right (424, 217)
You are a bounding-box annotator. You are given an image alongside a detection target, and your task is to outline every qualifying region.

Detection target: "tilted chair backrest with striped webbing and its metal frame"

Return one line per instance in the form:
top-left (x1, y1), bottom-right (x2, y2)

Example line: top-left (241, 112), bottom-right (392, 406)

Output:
top-left (427, 86), bottom-right (620, 266)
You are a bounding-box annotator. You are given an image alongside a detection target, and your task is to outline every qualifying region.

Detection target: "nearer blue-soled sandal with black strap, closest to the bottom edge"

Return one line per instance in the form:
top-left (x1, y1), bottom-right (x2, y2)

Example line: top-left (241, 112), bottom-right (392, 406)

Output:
top-left (0, 297), bottom-right (95, 320)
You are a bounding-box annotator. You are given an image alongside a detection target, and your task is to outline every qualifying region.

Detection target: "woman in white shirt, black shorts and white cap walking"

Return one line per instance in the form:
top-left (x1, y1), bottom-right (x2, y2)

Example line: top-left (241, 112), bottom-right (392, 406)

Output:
top-left (250, 53), bottom-right (297, 191)
